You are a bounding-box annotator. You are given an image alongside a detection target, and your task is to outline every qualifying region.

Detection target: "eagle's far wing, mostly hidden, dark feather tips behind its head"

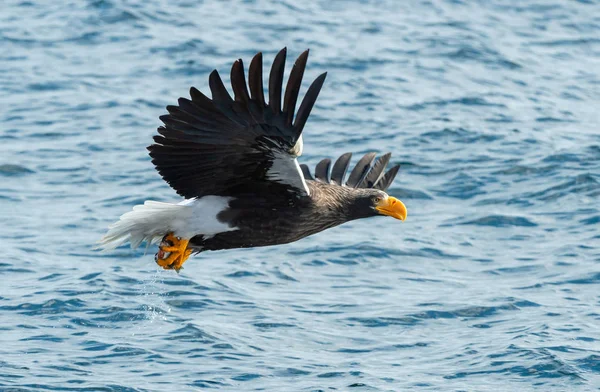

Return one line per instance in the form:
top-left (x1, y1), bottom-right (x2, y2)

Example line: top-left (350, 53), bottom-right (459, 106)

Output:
top-left (300, 152), bottom-right (400, 191)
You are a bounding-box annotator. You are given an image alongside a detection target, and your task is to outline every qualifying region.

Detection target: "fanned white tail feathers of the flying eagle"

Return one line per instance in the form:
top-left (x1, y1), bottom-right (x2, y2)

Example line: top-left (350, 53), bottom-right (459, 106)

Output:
top-left (96, 200), bottom-right (189, 250)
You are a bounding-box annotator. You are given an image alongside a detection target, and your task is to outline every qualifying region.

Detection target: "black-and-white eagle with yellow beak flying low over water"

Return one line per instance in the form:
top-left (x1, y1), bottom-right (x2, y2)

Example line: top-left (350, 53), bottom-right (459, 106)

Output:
top-left (99, 48), bottom-right (407, 271)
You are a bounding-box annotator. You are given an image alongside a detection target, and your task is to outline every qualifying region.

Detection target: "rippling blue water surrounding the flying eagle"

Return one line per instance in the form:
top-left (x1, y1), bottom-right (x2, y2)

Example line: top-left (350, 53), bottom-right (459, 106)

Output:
top-left (0, 0), bottom-right (600, 392)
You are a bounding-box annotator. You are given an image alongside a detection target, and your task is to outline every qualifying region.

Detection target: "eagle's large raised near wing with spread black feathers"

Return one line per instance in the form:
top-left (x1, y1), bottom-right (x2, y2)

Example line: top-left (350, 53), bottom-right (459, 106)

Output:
top-left (148, 48), bottom-right (326, 198)
